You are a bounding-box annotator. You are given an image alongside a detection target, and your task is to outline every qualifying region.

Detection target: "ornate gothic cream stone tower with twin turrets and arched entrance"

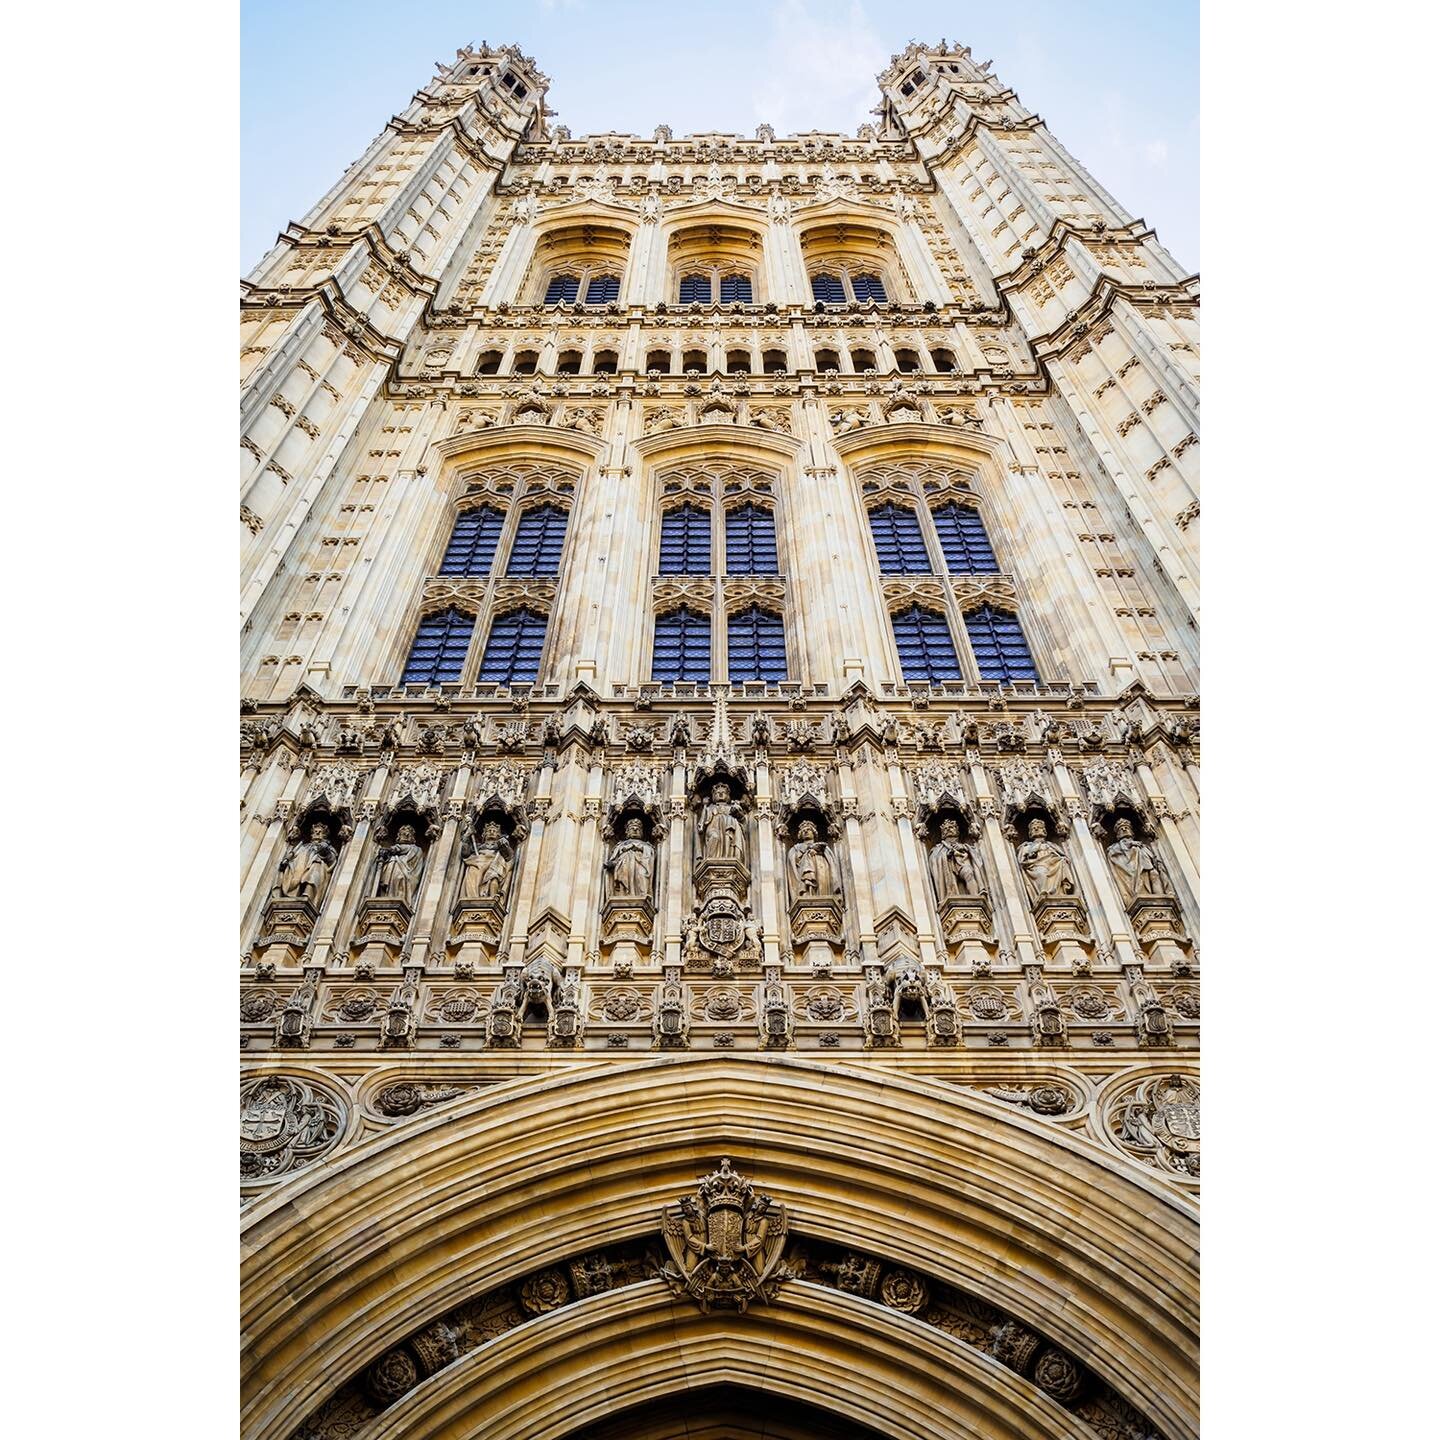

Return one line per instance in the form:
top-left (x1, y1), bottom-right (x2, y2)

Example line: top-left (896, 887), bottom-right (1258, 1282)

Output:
top-left (240, 45), bottom-right (1200, 1440)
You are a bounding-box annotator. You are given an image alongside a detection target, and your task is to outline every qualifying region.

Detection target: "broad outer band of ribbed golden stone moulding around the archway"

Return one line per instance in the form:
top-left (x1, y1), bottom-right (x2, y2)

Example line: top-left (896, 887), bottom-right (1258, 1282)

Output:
top-left (243, 1056), bottom-right (1198, 1440)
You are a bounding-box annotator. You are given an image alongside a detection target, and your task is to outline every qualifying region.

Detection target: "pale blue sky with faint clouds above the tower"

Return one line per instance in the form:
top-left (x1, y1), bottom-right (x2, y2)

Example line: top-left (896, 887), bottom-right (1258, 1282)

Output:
top-left (239, 0), bottom-right (1200, 272)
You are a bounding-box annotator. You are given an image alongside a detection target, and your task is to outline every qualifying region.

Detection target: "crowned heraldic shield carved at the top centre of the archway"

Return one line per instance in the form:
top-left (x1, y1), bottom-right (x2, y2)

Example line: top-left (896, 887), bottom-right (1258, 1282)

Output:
top-left (661, 1159), bottom-right (789, 1312)
